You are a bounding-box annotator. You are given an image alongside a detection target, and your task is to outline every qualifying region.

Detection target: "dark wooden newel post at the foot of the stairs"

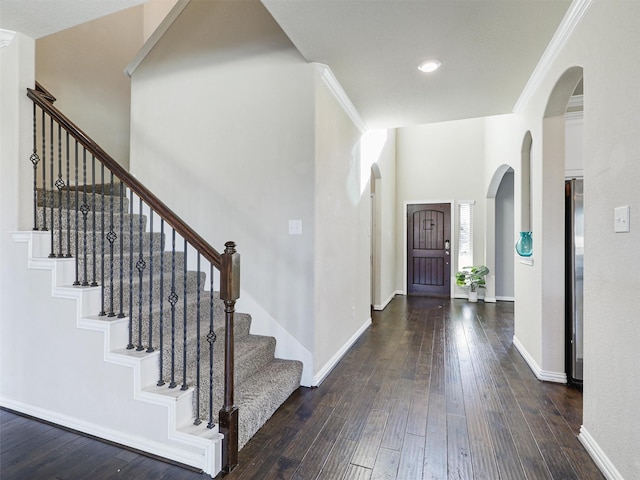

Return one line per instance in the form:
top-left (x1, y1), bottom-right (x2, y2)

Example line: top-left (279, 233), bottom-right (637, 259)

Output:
top-left (219, 242), bottom-right (240, 473)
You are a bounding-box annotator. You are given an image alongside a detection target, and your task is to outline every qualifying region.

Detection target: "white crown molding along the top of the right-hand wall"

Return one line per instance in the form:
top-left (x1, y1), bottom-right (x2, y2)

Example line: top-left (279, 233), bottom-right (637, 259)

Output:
top-left (513, 0), bottom-right (593, 113)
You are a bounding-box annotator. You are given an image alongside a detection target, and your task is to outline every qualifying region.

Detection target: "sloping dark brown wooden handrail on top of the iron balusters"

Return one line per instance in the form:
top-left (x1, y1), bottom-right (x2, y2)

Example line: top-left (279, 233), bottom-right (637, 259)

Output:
top-left (27, 84), bottom-right (222, 270)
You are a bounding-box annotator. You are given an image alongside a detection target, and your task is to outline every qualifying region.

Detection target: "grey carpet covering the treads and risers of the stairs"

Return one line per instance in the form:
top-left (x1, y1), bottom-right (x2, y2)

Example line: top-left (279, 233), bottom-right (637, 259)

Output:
top-left (36, 186), bottom-right (302, 448)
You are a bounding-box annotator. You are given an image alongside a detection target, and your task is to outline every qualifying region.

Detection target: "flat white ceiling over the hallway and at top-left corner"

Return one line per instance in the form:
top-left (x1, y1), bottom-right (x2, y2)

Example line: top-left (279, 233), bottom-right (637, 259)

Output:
top-left (0, 0), bottom-right (571, 128)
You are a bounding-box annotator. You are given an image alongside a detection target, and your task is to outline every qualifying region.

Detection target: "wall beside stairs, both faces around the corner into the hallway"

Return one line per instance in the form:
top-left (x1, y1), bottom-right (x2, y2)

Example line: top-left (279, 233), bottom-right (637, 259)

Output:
top-left (131, 2), bottom-right (369, 382)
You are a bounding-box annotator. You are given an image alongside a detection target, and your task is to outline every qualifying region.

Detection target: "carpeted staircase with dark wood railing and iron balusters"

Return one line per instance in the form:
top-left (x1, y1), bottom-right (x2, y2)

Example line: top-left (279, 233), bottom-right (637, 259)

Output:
top-left (16, 83), bottom-right (302, 476)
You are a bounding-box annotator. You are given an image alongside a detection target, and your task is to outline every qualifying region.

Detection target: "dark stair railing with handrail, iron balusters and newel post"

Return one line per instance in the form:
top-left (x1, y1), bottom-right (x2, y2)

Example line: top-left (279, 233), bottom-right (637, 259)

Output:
top-left (27, 83), bottom-right (240, 472)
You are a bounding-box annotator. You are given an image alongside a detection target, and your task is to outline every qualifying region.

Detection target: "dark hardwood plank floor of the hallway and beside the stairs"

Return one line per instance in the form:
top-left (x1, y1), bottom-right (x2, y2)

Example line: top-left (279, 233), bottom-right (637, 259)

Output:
top-left (0, 297), bottom-right (604, 480)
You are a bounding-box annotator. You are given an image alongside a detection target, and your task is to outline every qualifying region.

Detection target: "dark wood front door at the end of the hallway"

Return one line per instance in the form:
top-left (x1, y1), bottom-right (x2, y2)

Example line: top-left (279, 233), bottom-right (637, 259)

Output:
top-left (407, 203), bottom-right (451, 297)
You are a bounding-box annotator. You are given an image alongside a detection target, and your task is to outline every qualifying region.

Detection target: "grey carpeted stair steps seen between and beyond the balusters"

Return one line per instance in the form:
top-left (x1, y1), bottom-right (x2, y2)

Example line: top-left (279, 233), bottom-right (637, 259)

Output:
top-left (37, 185), bottom-right (302, 448)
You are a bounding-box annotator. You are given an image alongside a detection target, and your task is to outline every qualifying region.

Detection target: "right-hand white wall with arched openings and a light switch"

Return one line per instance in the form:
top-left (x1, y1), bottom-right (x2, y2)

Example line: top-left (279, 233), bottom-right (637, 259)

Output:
top-left (488, 1), bottom-right (640, 478)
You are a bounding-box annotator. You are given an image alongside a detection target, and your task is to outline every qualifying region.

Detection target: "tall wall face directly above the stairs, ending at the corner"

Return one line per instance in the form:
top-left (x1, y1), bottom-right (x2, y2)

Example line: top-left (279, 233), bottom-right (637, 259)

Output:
top-left (131, 2), bottom-right (314, 364)
